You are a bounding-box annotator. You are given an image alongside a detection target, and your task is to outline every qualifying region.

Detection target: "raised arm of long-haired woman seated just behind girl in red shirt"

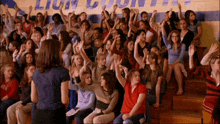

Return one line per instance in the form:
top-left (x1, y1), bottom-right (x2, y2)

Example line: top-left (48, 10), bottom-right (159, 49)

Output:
top-left (134, 36), bottom-right (145, 68)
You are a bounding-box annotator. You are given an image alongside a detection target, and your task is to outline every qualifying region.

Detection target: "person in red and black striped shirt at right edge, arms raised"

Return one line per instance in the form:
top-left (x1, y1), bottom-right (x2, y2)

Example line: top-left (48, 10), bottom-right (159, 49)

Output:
top-left (189, 43), bottom-right (220, 123)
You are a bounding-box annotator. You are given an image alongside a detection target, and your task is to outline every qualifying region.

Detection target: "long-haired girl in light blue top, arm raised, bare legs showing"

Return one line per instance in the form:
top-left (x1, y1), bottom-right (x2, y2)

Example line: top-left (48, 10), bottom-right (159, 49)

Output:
top-left (161, 21), bottom-right (186, 95)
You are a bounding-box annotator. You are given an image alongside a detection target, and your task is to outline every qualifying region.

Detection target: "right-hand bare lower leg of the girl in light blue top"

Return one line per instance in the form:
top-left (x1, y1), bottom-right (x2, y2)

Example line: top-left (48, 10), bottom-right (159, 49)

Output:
top-left (174, 63), bottom-right (183, 95)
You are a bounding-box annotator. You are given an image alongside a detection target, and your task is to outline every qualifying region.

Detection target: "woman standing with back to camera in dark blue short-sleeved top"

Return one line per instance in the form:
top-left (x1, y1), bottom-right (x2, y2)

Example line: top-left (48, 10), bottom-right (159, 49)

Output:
top-left (31, 40), bottom-right (70, 124)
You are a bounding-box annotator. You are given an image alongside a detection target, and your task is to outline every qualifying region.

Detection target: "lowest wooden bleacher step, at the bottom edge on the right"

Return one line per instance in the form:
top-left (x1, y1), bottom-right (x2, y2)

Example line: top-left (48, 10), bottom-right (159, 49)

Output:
top-left (160, 110), bottom-right (202, 124)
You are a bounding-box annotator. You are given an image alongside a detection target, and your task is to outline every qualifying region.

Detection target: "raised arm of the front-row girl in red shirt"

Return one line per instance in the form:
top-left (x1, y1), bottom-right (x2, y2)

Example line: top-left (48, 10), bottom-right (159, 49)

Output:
top-left (114, 55), bottom-right (126, 87)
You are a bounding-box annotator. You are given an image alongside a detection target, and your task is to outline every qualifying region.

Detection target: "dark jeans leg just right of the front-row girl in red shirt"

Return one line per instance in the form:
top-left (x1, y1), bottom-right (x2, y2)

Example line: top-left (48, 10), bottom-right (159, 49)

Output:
top-left (146, 90), bottom-right (156, 123)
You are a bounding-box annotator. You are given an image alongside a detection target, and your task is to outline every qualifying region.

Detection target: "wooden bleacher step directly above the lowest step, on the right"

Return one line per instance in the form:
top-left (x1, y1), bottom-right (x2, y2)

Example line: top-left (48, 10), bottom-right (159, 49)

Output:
top-left (173, 94), bottom-right (205, 112)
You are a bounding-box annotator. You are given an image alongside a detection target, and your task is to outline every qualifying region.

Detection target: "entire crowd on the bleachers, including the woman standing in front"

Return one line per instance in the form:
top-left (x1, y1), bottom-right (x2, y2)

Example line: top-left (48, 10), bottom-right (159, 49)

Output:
top-left (0, 4), bottom-right (220, 124)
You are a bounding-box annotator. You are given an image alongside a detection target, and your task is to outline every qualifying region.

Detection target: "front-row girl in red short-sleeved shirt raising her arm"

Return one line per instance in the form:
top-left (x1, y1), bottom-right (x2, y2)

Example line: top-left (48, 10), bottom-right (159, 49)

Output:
top-left (113, 56), bottom-right (147, 124)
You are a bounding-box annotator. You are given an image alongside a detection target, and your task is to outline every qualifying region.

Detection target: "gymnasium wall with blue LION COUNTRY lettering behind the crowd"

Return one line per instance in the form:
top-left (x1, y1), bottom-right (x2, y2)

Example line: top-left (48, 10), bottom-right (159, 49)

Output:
top-left (0, 0), bottom-right (220, 47)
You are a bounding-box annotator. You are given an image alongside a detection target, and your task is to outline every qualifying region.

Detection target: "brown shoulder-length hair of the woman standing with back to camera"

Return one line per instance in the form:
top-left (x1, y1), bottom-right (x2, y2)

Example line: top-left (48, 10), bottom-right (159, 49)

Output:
top-left (36, 39), bottom-right (62, 72)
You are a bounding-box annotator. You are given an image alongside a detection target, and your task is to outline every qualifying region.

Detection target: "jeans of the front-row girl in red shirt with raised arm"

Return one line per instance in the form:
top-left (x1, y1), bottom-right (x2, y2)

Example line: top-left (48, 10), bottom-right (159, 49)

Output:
top-left (113, 113), bottom-right (144, 124)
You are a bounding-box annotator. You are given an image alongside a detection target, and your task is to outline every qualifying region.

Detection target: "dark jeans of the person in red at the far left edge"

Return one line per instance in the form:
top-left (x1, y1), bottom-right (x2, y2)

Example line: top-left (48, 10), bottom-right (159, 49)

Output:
top-left (0, 99), bottom-right (17, 122)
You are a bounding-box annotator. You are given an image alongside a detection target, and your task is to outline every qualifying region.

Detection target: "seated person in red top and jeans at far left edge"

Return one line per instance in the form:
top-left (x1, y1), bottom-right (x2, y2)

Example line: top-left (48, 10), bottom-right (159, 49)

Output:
top-left (0, 64), bottom-right (19, 123)
